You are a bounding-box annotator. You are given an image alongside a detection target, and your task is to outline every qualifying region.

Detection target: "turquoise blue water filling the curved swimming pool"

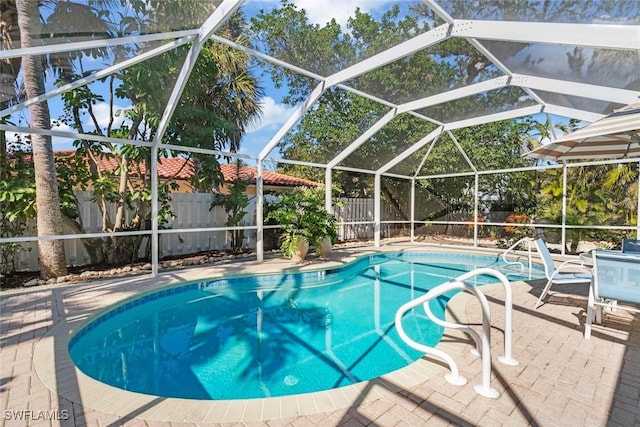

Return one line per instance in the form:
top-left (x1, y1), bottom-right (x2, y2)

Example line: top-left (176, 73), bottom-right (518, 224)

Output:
top-left (69, 253), bottom-right (542, 399)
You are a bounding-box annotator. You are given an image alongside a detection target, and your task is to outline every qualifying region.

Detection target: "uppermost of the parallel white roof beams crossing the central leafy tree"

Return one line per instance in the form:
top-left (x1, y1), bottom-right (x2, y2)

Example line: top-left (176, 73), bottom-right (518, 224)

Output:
top-left (326, 24), bottom-right (450, 86)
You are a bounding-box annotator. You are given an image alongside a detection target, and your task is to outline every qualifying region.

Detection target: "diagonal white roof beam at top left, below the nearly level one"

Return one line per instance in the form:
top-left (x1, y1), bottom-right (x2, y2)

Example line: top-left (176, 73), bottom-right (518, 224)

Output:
top-left (0, 36), bottom-right (193, 117)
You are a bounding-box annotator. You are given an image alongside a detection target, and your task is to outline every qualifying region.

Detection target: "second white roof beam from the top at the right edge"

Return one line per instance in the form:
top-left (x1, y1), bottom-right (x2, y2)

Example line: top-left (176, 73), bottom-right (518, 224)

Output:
top-left (510, 74), bottom-right (640, 105)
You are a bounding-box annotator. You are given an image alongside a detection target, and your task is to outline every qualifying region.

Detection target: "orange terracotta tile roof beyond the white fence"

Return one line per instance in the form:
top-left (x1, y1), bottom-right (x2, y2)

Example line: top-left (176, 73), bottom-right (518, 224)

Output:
top-left (56, 151), bottom-right (320, 187)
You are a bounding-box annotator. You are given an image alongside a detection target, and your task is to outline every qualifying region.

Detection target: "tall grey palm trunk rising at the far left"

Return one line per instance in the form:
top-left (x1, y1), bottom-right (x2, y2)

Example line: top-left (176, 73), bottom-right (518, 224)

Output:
top-left (16, 0), bottom-right (67, 279)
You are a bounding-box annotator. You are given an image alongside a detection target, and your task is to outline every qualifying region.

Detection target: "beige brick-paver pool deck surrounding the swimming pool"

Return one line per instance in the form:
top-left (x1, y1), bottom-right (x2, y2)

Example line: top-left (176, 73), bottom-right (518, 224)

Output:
top-left (0, 244), bottom-right (640, 427)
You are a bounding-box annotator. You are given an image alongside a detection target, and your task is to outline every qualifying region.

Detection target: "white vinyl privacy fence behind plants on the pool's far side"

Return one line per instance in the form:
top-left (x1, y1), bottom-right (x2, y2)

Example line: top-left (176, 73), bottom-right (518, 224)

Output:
top-left (6, 191), bottom-right (384, 271)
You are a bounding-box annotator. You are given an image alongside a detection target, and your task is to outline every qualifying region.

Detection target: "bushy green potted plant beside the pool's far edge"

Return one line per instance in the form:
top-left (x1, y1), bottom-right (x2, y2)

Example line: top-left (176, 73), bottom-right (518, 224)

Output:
top-left (267, 187), bottom-right (338, 260)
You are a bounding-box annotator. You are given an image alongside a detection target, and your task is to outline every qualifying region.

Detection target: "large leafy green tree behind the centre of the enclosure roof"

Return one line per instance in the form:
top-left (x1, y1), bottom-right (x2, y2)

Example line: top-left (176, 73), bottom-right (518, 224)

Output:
top-left (252, 1), bottom-right (536, 199)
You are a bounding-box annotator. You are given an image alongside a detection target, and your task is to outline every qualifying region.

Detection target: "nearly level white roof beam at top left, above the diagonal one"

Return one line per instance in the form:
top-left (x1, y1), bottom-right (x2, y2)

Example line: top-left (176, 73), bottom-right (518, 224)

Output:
top-left (0, 28), bottom-right (198, 60)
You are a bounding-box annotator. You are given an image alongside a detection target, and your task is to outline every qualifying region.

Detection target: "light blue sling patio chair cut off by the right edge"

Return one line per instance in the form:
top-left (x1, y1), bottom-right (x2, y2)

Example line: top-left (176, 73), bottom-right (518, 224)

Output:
top-left (584, 251), bottom-right (640, 340)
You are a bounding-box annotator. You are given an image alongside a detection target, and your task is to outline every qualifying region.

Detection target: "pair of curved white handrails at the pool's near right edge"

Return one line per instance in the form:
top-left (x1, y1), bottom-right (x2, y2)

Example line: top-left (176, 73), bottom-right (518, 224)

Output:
top-left (395, 268), bottom-right (518, 398)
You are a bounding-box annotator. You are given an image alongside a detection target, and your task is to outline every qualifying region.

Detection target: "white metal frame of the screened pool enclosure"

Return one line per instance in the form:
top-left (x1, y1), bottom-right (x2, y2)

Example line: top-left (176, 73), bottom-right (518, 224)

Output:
top-left (0, 0), bottom-right (640, 275)
